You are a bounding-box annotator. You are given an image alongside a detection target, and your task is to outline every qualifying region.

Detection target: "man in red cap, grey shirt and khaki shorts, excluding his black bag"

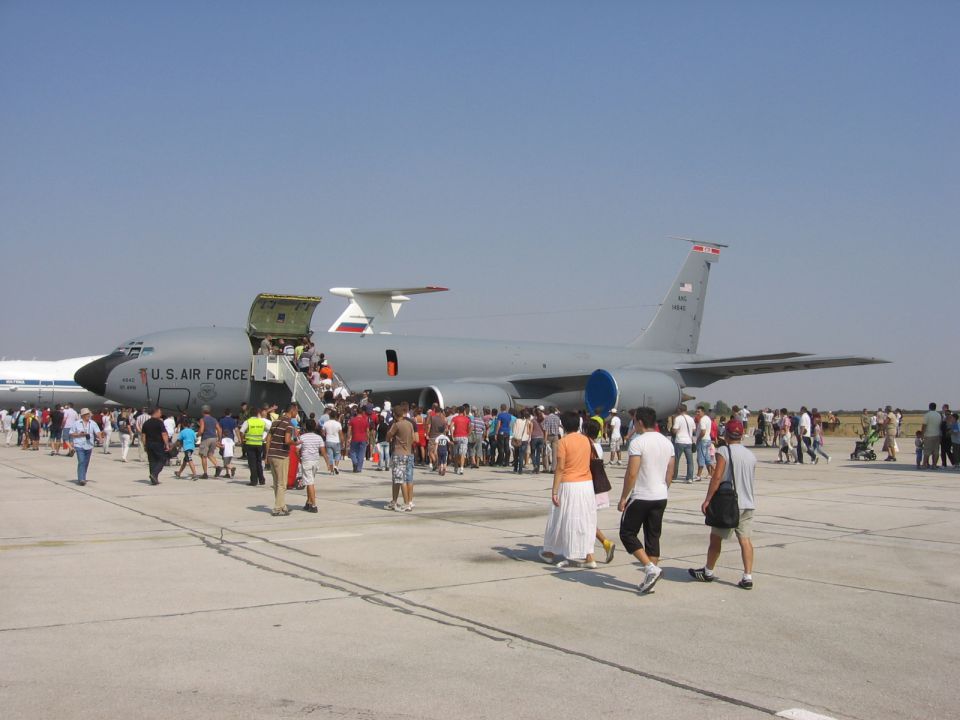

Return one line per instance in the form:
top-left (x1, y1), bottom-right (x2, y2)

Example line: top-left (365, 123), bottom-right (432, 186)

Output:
top-left (687, 417), bottom-right (757, 590)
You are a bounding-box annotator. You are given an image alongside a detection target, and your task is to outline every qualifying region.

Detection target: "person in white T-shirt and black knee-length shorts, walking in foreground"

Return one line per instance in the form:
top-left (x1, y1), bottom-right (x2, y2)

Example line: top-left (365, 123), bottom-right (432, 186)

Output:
top-left (617, 407), bottom-right (689, 593)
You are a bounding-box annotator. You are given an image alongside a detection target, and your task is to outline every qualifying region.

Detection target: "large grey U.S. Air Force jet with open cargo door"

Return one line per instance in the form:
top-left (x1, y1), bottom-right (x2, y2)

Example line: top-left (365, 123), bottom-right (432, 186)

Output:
top-left (75, 242), bottom-right (887, 417)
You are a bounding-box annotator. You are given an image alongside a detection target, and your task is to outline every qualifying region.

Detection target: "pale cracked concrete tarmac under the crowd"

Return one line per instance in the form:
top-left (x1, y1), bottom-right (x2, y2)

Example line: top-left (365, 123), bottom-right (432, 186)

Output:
top-left (0, 440), bottom-right (960, 720)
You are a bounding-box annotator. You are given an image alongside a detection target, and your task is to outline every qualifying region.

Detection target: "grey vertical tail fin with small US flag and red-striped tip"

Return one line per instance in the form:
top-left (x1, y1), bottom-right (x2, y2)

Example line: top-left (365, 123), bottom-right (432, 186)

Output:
top-left (627, 238), bottom-right (726, 354)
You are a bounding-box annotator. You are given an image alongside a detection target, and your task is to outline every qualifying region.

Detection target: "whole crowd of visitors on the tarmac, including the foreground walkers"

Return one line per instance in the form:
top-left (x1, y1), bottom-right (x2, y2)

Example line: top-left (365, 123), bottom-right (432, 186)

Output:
top-left (0, 396), bottom-right (960, 593)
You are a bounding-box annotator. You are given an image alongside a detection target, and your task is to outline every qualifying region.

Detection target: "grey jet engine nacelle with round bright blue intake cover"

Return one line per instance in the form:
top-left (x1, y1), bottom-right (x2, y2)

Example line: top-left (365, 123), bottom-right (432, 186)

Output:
top-left (584, 370), bottom-right (681, 419)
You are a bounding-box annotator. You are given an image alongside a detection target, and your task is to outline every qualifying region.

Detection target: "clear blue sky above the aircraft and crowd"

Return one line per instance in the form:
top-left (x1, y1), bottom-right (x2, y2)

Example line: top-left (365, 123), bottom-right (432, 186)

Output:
top-left (0, 0), bottom-right (960, 407)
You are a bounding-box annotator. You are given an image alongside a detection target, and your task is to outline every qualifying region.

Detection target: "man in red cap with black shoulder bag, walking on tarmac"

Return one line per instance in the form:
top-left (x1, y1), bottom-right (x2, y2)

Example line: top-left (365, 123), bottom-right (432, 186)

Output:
top-left (687, 419), bottom-right (757, 590)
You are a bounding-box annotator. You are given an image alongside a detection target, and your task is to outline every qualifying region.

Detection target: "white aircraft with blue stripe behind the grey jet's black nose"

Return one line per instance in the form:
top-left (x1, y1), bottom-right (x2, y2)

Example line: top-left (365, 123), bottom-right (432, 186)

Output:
top-left (0, 355), bottom-right (116, 410)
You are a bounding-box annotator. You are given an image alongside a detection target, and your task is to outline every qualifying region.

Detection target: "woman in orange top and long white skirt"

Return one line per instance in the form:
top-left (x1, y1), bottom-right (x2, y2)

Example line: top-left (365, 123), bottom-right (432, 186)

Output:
top-left (540, 412), bottom-right (597, 569)
